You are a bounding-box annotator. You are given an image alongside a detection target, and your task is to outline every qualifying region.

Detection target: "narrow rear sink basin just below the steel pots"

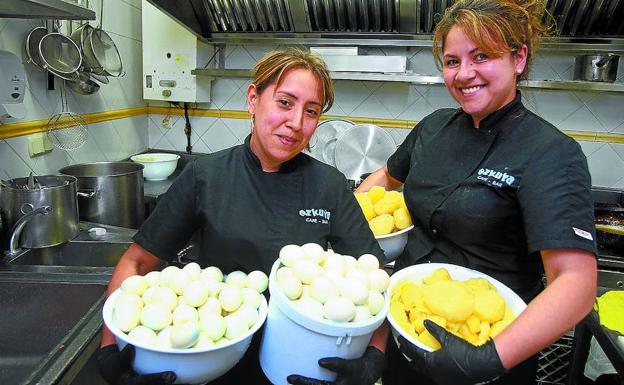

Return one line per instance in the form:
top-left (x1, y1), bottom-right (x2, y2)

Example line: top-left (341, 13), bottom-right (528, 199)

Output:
top-left (8, 242), bottom-right (130, 267)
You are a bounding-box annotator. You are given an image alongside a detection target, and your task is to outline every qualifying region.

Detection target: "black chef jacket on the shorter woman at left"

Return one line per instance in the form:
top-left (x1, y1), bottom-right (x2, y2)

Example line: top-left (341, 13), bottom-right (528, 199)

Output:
top-left (134, 137), bottom-right (383, 274)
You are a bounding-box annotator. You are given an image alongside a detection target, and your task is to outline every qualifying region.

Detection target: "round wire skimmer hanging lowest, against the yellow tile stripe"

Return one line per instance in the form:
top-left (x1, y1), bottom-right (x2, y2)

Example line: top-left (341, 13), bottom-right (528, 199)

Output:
top-left (48, 80), bottom-right (89, 151)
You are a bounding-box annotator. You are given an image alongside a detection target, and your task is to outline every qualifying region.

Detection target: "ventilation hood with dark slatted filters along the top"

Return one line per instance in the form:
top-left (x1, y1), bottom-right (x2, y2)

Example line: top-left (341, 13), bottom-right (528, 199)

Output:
top-left (148, 0), bottom-right (624, 40)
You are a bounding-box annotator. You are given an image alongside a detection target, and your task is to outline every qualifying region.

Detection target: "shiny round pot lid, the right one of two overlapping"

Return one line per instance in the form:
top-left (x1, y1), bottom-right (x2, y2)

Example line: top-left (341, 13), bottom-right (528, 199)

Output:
top-left (335, 124), bottom-right (396, 180)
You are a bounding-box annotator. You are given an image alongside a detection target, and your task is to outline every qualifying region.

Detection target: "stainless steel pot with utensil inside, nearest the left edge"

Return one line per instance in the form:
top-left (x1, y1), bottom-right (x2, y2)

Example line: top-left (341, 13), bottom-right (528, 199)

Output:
top-left (0, 175), bottom-right (79, 249)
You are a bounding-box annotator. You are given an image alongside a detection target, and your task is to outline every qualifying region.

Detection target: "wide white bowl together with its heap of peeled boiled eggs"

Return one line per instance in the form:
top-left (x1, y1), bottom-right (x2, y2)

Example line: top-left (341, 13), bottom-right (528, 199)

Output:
top-left (103, 262), bottom-right (268, 384)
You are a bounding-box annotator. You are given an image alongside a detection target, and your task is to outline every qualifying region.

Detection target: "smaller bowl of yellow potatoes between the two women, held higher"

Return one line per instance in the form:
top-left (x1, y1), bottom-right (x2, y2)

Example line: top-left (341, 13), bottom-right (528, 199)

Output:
top-left (355, 186), bottom-right (414, 262)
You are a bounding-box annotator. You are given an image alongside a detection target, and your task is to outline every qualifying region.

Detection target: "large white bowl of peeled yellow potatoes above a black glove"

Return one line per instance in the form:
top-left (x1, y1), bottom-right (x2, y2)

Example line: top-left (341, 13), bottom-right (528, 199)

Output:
top-left (388, 263), bottom-right (526, 351)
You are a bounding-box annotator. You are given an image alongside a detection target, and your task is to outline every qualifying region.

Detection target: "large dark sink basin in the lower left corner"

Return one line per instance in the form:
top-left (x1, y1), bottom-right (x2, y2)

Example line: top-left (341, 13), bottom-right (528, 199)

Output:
top-left (0, 280), bottom-right (106, 384)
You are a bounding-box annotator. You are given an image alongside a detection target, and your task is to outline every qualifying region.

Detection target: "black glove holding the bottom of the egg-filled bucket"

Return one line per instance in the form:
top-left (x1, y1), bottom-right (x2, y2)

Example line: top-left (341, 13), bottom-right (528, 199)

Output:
top-left (287, 346), bottom-right (386, 385)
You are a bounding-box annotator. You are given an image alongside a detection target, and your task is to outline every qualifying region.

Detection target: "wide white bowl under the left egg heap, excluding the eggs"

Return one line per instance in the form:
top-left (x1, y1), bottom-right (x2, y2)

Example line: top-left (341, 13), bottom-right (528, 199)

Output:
top-left (102, 289), bottom-right (268, 384)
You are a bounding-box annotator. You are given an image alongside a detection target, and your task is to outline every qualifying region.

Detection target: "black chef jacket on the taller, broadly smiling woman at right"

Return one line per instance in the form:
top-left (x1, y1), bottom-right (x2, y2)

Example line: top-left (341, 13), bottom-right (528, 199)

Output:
top-left (387, 92), bottom-right (596, 301)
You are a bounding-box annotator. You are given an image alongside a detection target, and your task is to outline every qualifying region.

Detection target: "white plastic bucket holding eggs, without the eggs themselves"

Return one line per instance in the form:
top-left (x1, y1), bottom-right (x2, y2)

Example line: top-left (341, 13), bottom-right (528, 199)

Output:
top-left (260, 260), bottom-right (390, 385)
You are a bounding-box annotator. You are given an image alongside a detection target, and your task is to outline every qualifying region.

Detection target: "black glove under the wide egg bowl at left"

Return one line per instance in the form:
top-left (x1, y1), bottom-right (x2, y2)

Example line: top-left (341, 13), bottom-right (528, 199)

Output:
top-left (95, 344), bottom-right (176, 385)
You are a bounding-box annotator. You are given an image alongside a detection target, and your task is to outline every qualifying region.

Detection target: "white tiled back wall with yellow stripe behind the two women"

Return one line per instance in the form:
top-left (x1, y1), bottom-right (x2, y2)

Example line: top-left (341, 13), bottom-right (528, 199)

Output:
top-left (148, 45), bottom-right (624, 188)
